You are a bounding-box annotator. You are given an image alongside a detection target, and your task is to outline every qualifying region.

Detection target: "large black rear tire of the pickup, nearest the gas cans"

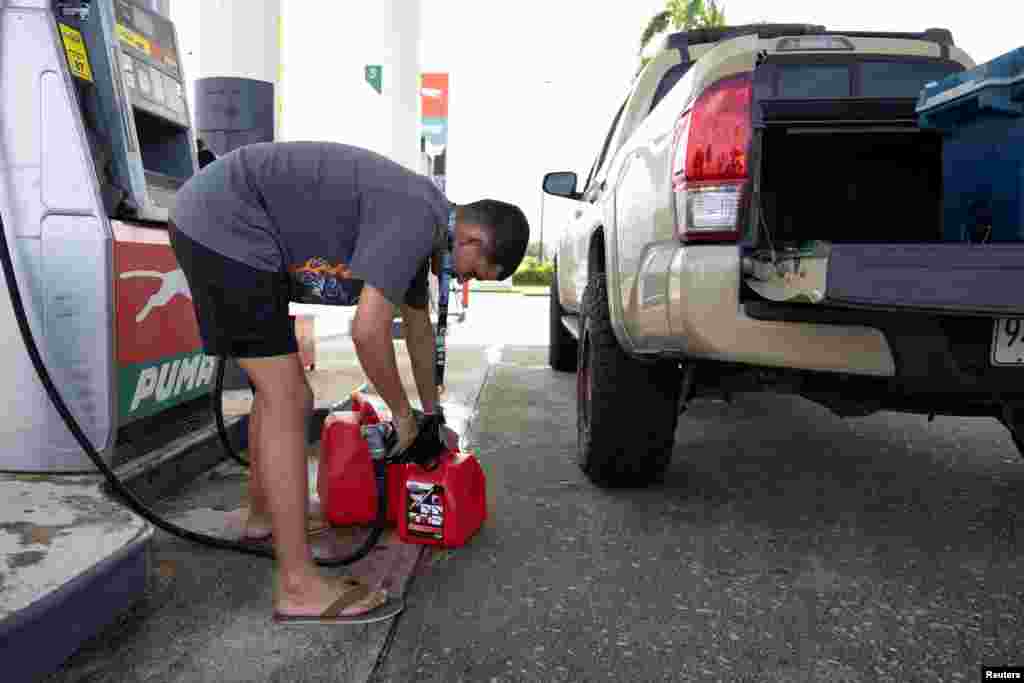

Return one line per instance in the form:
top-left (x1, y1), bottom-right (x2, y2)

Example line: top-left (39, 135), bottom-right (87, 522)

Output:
top-left (577, 272), bottom-right (682, 487)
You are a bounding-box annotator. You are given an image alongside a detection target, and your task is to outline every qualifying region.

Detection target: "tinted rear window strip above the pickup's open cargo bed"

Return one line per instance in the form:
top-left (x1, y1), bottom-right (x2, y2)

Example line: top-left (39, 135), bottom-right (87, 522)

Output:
top-left (770, 59), bottom-right (964, 99)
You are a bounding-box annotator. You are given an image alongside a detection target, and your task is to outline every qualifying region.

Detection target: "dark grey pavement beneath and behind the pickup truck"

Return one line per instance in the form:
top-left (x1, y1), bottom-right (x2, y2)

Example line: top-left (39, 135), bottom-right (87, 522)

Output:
top-left (375, 346), bottom-right (1024, 683)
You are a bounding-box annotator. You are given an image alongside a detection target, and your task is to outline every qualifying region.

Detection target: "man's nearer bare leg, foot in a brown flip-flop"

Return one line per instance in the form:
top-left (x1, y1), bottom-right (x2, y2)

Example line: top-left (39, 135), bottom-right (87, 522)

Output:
top-left (239, 353), bottom-right (380, 615)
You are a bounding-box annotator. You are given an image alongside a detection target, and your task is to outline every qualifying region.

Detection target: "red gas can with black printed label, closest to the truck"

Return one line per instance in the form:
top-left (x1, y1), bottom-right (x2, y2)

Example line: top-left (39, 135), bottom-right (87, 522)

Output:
top-left (388, 451), bottom-right (487, 548)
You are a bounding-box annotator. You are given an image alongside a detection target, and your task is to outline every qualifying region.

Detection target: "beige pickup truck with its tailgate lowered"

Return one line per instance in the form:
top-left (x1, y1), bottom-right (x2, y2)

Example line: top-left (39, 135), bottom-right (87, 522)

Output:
top-left (543, 24), bottom-right (1024, 486)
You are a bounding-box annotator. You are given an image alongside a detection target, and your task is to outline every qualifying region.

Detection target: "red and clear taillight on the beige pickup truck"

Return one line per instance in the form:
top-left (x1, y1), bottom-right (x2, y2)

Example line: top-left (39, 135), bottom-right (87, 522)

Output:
top-left (672, 75), bottom-right (753, 242)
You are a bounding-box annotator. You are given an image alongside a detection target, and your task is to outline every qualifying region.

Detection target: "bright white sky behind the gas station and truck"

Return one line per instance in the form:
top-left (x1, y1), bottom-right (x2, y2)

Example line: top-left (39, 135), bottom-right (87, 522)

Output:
top-left (172, 0), bottom-right (1024, 253)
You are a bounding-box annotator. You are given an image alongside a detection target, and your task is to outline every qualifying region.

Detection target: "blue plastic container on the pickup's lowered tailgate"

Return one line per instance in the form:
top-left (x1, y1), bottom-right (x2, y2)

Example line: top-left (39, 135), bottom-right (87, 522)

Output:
top-left (918, 47), bottom-right (1024, 243)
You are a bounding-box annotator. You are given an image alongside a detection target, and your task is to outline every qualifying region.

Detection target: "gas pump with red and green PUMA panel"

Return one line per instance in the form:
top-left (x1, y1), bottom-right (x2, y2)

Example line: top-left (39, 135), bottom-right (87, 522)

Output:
top-left (0, 0), bottom-right (216, 472)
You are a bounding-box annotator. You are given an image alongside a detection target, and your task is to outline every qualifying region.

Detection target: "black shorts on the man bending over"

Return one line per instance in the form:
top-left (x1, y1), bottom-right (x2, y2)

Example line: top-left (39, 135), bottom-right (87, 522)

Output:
top-left (169, 223), bottom-right (299, 358)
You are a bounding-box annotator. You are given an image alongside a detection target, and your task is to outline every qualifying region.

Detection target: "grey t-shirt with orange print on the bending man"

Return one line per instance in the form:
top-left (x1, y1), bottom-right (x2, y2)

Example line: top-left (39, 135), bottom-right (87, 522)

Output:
top-left (171, 142), bottom-right (452, 307)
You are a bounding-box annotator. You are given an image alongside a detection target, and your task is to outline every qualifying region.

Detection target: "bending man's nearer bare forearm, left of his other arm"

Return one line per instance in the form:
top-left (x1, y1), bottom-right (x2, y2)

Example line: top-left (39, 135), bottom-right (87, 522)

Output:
top-left (352, 283), bottom-right (413, 418)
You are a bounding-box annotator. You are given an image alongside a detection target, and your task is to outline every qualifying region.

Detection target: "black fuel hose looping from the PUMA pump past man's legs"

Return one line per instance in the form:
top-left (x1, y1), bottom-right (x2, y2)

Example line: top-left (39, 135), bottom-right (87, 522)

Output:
top-left (0, 217), bottom-right (387, 566)
